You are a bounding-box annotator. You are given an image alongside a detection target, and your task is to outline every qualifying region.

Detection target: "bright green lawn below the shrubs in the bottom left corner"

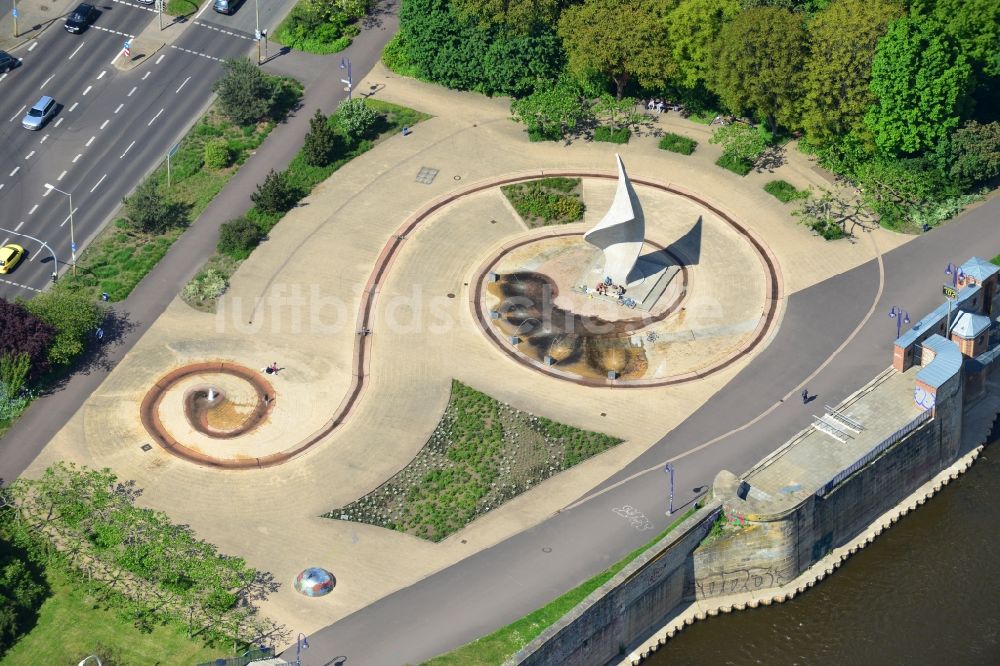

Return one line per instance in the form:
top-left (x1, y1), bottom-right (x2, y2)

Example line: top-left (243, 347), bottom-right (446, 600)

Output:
top-left (0, 569), bottom-right (227, 666)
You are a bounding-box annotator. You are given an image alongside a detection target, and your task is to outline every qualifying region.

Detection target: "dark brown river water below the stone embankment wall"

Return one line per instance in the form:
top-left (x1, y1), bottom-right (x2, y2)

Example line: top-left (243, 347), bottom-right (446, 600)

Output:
top-left (645, 443), bottom-right (1000, 666)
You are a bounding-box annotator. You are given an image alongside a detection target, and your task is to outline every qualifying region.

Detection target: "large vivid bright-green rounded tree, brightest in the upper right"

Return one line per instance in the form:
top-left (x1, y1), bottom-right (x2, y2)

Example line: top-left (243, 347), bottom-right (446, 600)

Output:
top-left (865, 18), bottom-right (972, 154)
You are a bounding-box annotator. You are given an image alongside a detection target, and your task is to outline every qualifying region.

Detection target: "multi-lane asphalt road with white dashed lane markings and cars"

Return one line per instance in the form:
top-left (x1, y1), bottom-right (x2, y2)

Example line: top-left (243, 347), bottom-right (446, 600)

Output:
top-left (0, 1), bottom-right (284, 300)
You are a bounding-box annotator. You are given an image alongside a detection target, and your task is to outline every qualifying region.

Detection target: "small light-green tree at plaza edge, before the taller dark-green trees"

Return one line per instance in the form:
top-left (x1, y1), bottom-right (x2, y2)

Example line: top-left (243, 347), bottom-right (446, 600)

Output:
top-left (510, 77), bottom-right (591, 141)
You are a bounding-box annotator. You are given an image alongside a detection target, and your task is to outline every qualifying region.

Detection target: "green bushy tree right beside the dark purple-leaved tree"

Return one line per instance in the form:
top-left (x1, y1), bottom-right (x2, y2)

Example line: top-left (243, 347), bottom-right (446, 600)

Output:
top-left (24, 289), bottom-right (107, 366)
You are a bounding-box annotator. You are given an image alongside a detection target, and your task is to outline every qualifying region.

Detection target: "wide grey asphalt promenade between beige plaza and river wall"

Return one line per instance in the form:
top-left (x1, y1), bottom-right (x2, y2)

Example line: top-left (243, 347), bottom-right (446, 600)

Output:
top-left (286, 193), bottom-right (1000, 666)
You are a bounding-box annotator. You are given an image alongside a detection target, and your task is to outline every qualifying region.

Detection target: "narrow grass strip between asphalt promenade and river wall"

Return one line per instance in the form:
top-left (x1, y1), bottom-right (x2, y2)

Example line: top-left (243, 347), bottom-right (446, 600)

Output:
top-left (425, 504), bottom-right (700, 666)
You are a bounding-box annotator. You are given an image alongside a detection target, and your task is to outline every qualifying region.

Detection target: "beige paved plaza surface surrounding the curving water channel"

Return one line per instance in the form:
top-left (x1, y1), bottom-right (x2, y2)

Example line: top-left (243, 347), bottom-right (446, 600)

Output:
top-left (19, 55), bottom-right (907, 648)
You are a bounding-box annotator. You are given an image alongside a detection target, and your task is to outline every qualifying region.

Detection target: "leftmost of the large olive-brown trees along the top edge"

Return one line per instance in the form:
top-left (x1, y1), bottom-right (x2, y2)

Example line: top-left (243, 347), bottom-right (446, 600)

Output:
top-left (558, 0), bottom-right (672, 99)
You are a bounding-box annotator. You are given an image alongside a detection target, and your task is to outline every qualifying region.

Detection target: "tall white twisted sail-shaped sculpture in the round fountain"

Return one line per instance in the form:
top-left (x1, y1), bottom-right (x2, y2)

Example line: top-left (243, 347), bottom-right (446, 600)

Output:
top-left (583, 155), bottom-right (646, 285)
